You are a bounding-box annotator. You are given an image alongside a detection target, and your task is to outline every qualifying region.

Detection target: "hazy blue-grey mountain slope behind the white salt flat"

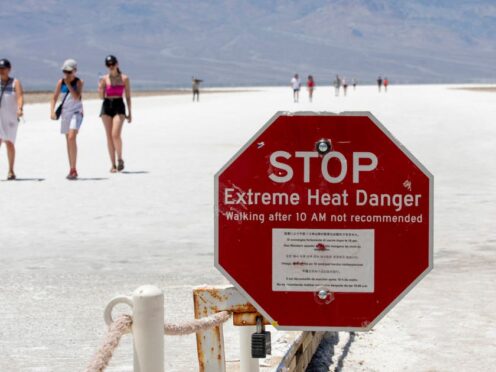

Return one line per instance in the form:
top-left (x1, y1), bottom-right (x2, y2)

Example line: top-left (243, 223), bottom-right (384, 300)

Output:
top-left (0, 0), bottom-right (496, 89)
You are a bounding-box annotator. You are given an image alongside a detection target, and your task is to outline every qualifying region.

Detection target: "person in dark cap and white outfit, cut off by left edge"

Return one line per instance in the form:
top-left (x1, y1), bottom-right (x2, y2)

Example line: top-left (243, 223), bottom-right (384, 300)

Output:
top-left (0, 58), bottom-right (24, 181)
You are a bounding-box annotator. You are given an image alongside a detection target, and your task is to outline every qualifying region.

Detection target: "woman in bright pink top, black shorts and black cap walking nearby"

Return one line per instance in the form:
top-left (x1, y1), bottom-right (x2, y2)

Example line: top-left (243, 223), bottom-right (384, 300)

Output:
top-left (98, 55), bottom-right (132, 173)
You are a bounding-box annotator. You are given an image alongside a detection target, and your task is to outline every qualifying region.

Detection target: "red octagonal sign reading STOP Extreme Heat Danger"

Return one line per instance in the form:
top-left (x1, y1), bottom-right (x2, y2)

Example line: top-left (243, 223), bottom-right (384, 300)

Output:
top-left (215, 113), bottom-right (433, 330)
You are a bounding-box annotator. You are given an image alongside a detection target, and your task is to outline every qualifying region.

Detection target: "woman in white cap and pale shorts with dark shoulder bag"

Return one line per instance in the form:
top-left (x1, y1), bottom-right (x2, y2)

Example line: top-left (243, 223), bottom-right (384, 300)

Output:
top-left (50, 59), bottom-right (84, 180)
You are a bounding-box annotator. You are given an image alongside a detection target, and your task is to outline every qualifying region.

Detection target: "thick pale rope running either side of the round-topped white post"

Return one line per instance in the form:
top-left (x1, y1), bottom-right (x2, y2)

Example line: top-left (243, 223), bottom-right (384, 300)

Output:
top-left (86, 311), bottom-right (231, 372)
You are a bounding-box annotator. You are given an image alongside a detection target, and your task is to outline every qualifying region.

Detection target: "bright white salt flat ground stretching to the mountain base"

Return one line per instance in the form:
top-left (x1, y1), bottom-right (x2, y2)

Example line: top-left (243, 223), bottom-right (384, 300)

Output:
top-left (0, 85), bottom-right (496, 371)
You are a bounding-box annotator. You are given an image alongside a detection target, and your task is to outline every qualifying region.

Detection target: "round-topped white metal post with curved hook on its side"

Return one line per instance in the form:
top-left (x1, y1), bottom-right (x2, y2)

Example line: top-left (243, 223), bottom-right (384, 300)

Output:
top-left (104, 285), bottom-right (164, 372)
